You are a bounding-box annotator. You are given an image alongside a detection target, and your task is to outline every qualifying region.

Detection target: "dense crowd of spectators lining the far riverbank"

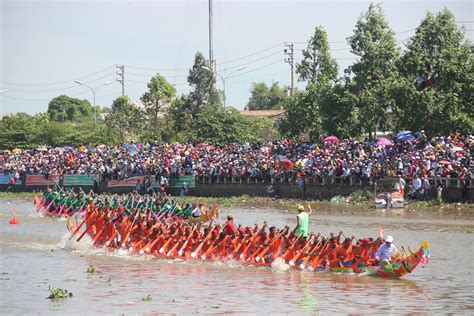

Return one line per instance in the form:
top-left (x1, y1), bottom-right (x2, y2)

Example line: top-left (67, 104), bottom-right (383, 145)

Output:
top-left (0, 131), bottom-right (474, 190)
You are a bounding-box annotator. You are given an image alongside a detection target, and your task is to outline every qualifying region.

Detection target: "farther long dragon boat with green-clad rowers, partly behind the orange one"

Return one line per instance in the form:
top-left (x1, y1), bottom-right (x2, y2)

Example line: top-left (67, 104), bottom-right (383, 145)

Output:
top-left (34, 187), bottom-right (219, 223)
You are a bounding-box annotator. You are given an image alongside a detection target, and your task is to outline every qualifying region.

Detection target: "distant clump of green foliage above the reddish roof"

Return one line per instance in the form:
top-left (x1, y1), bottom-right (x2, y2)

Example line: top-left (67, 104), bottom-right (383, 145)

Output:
top-left (246, 82), bottom-right (288, 110)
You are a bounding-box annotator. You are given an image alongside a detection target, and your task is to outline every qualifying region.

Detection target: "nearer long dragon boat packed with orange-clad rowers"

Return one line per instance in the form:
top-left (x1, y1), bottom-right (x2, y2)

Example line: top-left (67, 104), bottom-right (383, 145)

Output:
top-left (67, 209), bottom-right (430, 278)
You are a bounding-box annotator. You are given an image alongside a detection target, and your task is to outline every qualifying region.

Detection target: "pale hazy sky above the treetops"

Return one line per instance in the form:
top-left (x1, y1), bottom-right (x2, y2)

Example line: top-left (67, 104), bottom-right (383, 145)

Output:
top-left (0, 0), bottom-right (474, 114)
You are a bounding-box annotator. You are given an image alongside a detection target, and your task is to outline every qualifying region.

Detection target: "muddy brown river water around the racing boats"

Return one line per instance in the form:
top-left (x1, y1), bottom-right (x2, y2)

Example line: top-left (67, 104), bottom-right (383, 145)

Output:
top-left (0, 199), bottom-right (474, 315)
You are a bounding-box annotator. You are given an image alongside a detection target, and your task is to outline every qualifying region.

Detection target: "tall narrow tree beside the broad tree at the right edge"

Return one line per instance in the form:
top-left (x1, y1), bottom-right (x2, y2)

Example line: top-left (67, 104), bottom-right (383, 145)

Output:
top-left (346, 4), bottom-right (399, 137)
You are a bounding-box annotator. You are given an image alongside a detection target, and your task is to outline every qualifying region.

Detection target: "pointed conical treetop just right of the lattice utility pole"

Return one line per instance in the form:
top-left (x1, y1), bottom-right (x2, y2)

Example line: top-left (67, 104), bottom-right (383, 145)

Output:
top-left (296, 26), bottom-right (337, 84)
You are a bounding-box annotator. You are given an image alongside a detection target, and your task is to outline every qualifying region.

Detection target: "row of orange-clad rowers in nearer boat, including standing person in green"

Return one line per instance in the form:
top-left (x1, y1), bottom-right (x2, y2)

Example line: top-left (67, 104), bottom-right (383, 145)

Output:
top-left (86, 206), bottom-right (396, 269)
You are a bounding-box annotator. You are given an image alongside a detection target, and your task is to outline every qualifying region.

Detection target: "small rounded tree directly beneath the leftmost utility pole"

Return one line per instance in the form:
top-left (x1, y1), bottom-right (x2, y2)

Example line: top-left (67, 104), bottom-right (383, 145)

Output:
top-left (105, 96), bottom-right (142, 143)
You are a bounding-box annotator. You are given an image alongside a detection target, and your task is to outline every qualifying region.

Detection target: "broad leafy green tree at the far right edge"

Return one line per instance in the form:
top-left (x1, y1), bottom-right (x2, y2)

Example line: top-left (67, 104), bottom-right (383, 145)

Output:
top-left (392, 9), bottom-right (474, 134)
